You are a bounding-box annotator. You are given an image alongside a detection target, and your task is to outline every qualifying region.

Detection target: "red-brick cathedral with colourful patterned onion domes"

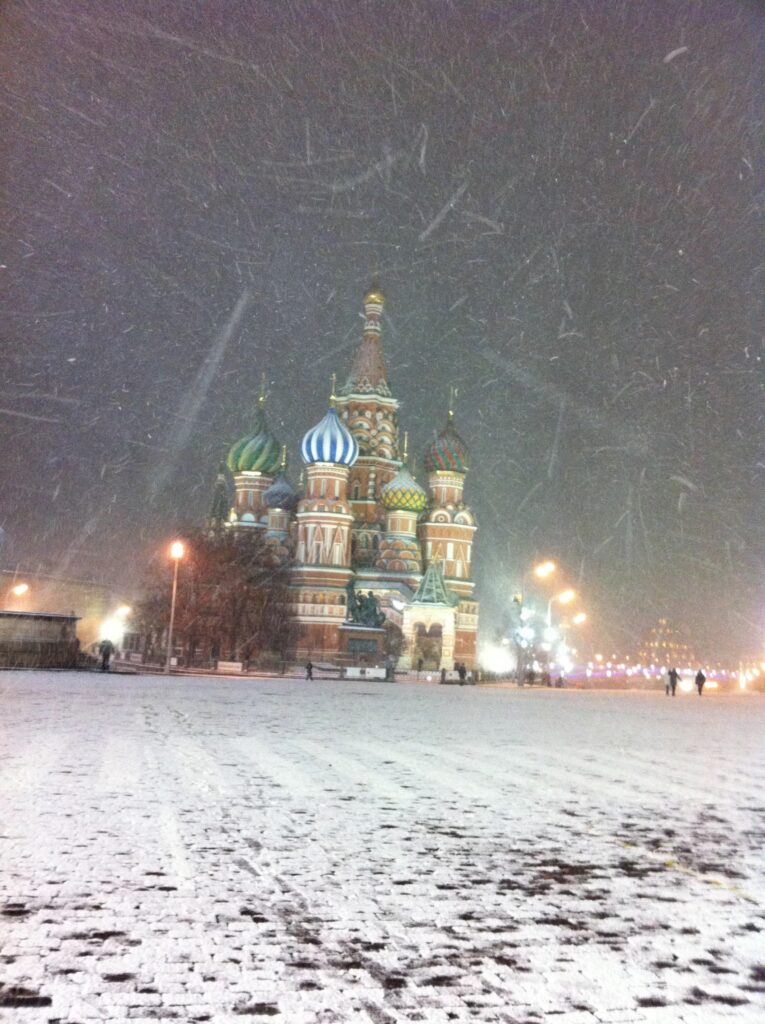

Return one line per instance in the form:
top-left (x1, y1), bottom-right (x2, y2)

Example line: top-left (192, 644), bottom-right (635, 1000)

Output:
top-left (208, 289), bottom-right (478, 670)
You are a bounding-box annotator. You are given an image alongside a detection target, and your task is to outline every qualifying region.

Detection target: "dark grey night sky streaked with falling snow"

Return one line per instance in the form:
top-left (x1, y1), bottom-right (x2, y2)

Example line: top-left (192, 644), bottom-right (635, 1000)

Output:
top-left (0, 0), bottom-right (765, 658)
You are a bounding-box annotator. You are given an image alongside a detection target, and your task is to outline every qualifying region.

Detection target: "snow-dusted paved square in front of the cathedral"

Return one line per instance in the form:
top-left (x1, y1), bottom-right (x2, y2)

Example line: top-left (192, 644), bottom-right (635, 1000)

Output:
top-left (0, 673), bottom-right (765, 1024)
